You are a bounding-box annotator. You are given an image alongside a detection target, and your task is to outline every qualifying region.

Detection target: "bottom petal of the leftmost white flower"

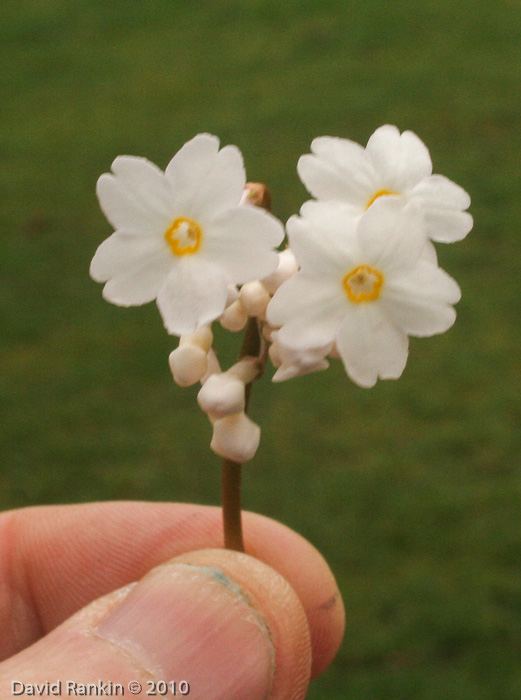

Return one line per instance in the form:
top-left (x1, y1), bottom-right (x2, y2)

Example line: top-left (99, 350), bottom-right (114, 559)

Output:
top-left (157, 256), bottom-right (229, 335)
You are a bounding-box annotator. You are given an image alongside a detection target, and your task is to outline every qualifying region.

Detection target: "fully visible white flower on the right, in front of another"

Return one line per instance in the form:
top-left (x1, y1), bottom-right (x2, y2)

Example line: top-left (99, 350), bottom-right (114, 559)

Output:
top-left (267, 197), bottom-right (460, 387)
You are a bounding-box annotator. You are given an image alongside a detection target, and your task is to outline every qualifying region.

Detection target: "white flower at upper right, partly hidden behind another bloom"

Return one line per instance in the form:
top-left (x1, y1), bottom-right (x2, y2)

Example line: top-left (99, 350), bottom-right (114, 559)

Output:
top-left (298, 125), bottom-right (472, 243)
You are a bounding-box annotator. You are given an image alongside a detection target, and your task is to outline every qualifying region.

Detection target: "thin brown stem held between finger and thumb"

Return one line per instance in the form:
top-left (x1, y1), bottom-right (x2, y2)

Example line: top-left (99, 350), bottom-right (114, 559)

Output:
top-left (222, 318), bottom-right (262, 552)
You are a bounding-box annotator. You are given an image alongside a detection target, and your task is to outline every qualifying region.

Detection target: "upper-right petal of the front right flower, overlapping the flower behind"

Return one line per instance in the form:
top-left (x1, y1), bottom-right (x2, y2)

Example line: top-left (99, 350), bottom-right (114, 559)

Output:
top-left (357, 197), bottom-right (427, 272)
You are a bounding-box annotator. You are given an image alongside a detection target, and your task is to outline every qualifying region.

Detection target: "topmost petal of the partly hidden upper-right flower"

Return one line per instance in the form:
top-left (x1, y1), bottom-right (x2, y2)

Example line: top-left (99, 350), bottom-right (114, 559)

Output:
top-left (366, 124), bottom-right (432, 192)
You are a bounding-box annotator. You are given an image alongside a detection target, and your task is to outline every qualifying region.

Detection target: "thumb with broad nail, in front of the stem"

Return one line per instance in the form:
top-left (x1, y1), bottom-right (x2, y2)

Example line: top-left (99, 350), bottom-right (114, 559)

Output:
top-left (0, 549), bottom-right (311, 700)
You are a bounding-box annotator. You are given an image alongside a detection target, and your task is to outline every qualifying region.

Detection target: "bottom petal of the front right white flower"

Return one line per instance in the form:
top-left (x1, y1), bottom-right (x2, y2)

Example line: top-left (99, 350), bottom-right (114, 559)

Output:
top-left (336, 304), bottom-right (409, 388)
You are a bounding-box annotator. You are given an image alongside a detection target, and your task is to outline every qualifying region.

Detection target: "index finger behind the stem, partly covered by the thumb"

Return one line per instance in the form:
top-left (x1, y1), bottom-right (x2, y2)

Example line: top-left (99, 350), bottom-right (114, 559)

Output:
top-left (0, 502), bottom-right (344, 675)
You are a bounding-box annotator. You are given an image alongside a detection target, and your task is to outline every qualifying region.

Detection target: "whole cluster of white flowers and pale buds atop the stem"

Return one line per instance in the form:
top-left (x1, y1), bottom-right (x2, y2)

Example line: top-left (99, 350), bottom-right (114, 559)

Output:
top-left (90, 125), bottom-right (472, 548)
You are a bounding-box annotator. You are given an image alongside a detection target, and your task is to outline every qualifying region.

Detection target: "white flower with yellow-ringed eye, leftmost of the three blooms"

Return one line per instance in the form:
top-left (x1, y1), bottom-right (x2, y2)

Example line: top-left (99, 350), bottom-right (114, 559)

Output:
top-left (90, 134), bottom-right (284, 335)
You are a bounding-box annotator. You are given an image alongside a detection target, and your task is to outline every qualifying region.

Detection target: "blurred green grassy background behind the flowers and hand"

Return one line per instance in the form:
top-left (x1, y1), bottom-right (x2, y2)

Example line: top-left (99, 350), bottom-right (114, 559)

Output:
top-left (0, 0), bottom-right (521, 700)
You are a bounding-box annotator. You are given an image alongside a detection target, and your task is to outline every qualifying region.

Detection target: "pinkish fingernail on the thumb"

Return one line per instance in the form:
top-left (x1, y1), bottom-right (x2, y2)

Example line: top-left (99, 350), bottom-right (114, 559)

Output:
top-left (96, 563), bottom-right (274, 700)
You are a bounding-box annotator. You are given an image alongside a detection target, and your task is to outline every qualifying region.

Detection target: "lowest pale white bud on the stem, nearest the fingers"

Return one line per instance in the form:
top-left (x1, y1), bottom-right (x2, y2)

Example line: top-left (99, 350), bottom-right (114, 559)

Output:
top-left (210, 412), bottom-right (260, 464)
